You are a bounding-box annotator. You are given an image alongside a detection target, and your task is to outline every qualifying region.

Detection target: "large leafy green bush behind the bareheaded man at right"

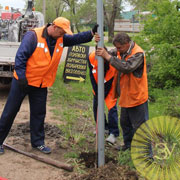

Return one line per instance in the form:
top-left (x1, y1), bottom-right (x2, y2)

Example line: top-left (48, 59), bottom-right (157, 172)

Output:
top-left (142, 0), bottom-right (180, 88)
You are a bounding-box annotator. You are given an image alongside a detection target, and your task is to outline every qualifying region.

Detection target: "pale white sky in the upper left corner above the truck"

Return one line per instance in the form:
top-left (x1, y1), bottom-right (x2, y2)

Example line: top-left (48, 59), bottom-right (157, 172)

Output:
top-left (0, 0), bottom-right (25, 9)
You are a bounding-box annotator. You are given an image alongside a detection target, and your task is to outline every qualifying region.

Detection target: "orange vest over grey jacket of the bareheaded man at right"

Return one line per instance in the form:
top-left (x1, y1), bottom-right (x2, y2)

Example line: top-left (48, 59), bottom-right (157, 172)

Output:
top-left (113, 44), bottom-right (148, 108)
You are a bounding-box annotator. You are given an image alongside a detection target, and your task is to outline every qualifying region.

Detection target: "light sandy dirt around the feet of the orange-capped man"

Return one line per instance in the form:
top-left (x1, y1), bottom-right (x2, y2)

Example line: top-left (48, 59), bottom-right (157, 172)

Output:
top-left (0, 85), bottom-right (71, 180)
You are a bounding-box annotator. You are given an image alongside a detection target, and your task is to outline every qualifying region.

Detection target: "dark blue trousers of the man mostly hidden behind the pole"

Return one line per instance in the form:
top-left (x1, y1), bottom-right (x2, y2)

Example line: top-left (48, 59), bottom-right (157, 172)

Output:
top-left (93, 96), bottom-right (119, 137)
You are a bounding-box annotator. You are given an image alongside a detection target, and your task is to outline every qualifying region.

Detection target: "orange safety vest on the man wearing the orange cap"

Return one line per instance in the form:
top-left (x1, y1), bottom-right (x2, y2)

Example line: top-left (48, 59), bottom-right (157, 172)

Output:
top-left (14, 27), bottom-right (63, 88)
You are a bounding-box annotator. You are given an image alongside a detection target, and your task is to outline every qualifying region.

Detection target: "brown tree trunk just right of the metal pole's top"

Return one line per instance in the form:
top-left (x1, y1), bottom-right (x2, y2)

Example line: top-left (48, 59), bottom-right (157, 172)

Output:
top-left (104, 0), bottom-right (122, 43)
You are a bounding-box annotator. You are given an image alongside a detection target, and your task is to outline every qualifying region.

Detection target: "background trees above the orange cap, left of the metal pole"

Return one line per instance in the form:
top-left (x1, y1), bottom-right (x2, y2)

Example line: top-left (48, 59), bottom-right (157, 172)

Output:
top-left (35, 0), bottom-right (95, 32)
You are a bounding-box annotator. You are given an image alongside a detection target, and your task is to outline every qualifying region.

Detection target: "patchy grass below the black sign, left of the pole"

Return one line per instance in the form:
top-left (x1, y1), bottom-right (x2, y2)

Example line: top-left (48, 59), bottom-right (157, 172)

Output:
top-left (51, 63), bottom-right (93, 147)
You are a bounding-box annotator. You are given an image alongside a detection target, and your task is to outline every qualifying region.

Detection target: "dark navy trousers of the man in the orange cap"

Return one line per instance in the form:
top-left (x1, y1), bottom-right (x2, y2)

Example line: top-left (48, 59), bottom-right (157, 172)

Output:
top-left (0, 78), bottom-right (47, 147)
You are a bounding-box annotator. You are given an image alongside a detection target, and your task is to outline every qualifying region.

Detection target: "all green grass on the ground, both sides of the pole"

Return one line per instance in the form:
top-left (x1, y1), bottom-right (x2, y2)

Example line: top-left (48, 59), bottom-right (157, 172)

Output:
top-left (50, 57), bottom-right (180, 175)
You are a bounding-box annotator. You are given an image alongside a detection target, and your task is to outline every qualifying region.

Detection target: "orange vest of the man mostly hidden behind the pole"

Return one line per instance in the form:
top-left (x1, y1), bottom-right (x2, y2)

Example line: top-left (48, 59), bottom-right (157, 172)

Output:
top-left (89, 51), bottom-right (117, 110)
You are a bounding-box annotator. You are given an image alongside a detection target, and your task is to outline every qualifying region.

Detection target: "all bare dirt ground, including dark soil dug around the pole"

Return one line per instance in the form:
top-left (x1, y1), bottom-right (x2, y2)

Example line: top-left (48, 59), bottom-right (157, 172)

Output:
top-left (0, 83), bottom-right (138, 180)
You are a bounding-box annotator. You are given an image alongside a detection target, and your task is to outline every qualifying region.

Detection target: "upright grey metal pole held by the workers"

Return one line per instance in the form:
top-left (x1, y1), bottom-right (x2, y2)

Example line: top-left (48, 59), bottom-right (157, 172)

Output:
top-left (97, 0), bottom-right (105, 167)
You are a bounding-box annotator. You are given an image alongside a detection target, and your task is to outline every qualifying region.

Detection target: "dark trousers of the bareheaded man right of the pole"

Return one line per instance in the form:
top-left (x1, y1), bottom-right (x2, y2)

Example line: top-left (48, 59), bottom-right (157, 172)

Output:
top-left (120, 102), bottom-right (149, 147)
